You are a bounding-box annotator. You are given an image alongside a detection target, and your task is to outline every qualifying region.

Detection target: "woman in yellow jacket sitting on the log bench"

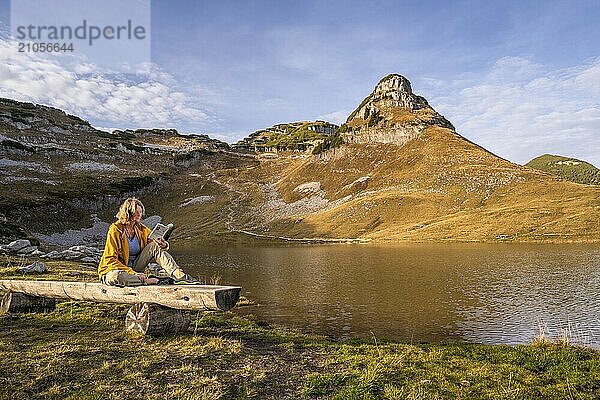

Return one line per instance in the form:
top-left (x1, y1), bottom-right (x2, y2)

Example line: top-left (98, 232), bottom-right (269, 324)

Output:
top-left (98, 197), bottom-right (197, 286)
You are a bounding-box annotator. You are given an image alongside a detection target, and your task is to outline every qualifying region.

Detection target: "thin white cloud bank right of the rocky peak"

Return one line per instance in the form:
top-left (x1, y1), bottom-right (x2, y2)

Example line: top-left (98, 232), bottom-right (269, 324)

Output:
top-left (423, 57), bottom-right (600, 166)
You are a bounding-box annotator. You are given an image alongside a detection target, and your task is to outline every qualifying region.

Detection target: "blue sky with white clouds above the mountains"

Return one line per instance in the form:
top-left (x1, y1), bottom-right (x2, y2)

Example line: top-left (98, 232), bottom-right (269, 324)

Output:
top-left (0, 0), bottom-right (600, 166)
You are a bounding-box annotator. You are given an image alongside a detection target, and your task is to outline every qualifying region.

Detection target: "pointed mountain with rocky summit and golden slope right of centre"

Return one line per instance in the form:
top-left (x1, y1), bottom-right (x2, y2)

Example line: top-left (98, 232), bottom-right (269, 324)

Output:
top-left (238, 74), bottom-right (600, 242)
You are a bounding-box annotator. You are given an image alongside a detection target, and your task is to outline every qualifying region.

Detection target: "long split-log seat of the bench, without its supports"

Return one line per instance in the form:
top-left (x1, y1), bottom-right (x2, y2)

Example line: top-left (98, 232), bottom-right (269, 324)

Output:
top-left (0, 279), bottom-right (241, 310)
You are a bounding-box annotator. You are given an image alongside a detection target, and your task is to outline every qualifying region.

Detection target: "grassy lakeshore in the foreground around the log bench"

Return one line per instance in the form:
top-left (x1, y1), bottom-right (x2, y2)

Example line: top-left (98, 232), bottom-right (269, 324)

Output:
top-left (0, 259), bottom-right (600, 399)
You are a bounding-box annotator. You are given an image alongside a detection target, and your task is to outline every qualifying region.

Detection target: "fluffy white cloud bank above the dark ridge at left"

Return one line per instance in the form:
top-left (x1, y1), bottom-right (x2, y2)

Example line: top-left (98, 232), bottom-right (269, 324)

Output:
top-left (0, 40), bottom-right (211, 128)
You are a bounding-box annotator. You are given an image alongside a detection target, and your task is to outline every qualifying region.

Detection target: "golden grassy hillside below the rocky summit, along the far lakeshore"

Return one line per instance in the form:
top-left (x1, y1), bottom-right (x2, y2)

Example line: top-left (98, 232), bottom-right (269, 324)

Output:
top-left (74, 127), bottom-right (600, 242)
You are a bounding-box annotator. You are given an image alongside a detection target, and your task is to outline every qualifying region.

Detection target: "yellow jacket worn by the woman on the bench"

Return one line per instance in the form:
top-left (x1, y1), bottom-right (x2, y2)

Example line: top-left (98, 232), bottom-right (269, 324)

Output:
top-left (98, 221), bottom-right (151, 278)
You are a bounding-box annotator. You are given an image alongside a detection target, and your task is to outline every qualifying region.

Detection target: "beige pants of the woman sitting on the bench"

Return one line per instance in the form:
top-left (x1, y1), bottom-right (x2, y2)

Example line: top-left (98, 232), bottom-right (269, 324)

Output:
top-left (101, 242), bottom-right (184, 286)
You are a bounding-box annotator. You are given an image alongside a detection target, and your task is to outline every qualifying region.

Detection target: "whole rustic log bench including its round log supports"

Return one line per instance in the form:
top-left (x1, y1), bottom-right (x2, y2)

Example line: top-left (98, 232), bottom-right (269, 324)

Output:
top-left (0, 280), bottom-right (241, 335)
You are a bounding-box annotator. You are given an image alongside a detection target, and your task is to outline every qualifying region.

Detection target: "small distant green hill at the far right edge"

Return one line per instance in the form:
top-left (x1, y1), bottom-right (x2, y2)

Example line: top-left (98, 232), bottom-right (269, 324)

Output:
top-left (525, 154), bottom-right (600, 185)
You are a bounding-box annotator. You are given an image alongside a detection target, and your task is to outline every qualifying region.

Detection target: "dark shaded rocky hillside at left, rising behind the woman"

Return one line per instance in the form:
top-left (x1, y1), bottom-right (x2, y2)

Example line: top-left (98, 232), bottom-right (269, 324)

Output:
top-left (0, 99), bottom-right (228, 240)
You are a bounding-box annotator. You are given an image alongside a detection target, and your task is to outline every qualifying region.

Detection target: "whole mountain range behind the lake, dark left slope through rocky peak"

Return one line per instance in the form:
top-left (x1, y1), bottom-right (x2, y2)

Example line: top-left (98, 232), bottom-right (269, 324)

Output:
top-left (0, 74), bottom-right (600, 246)
